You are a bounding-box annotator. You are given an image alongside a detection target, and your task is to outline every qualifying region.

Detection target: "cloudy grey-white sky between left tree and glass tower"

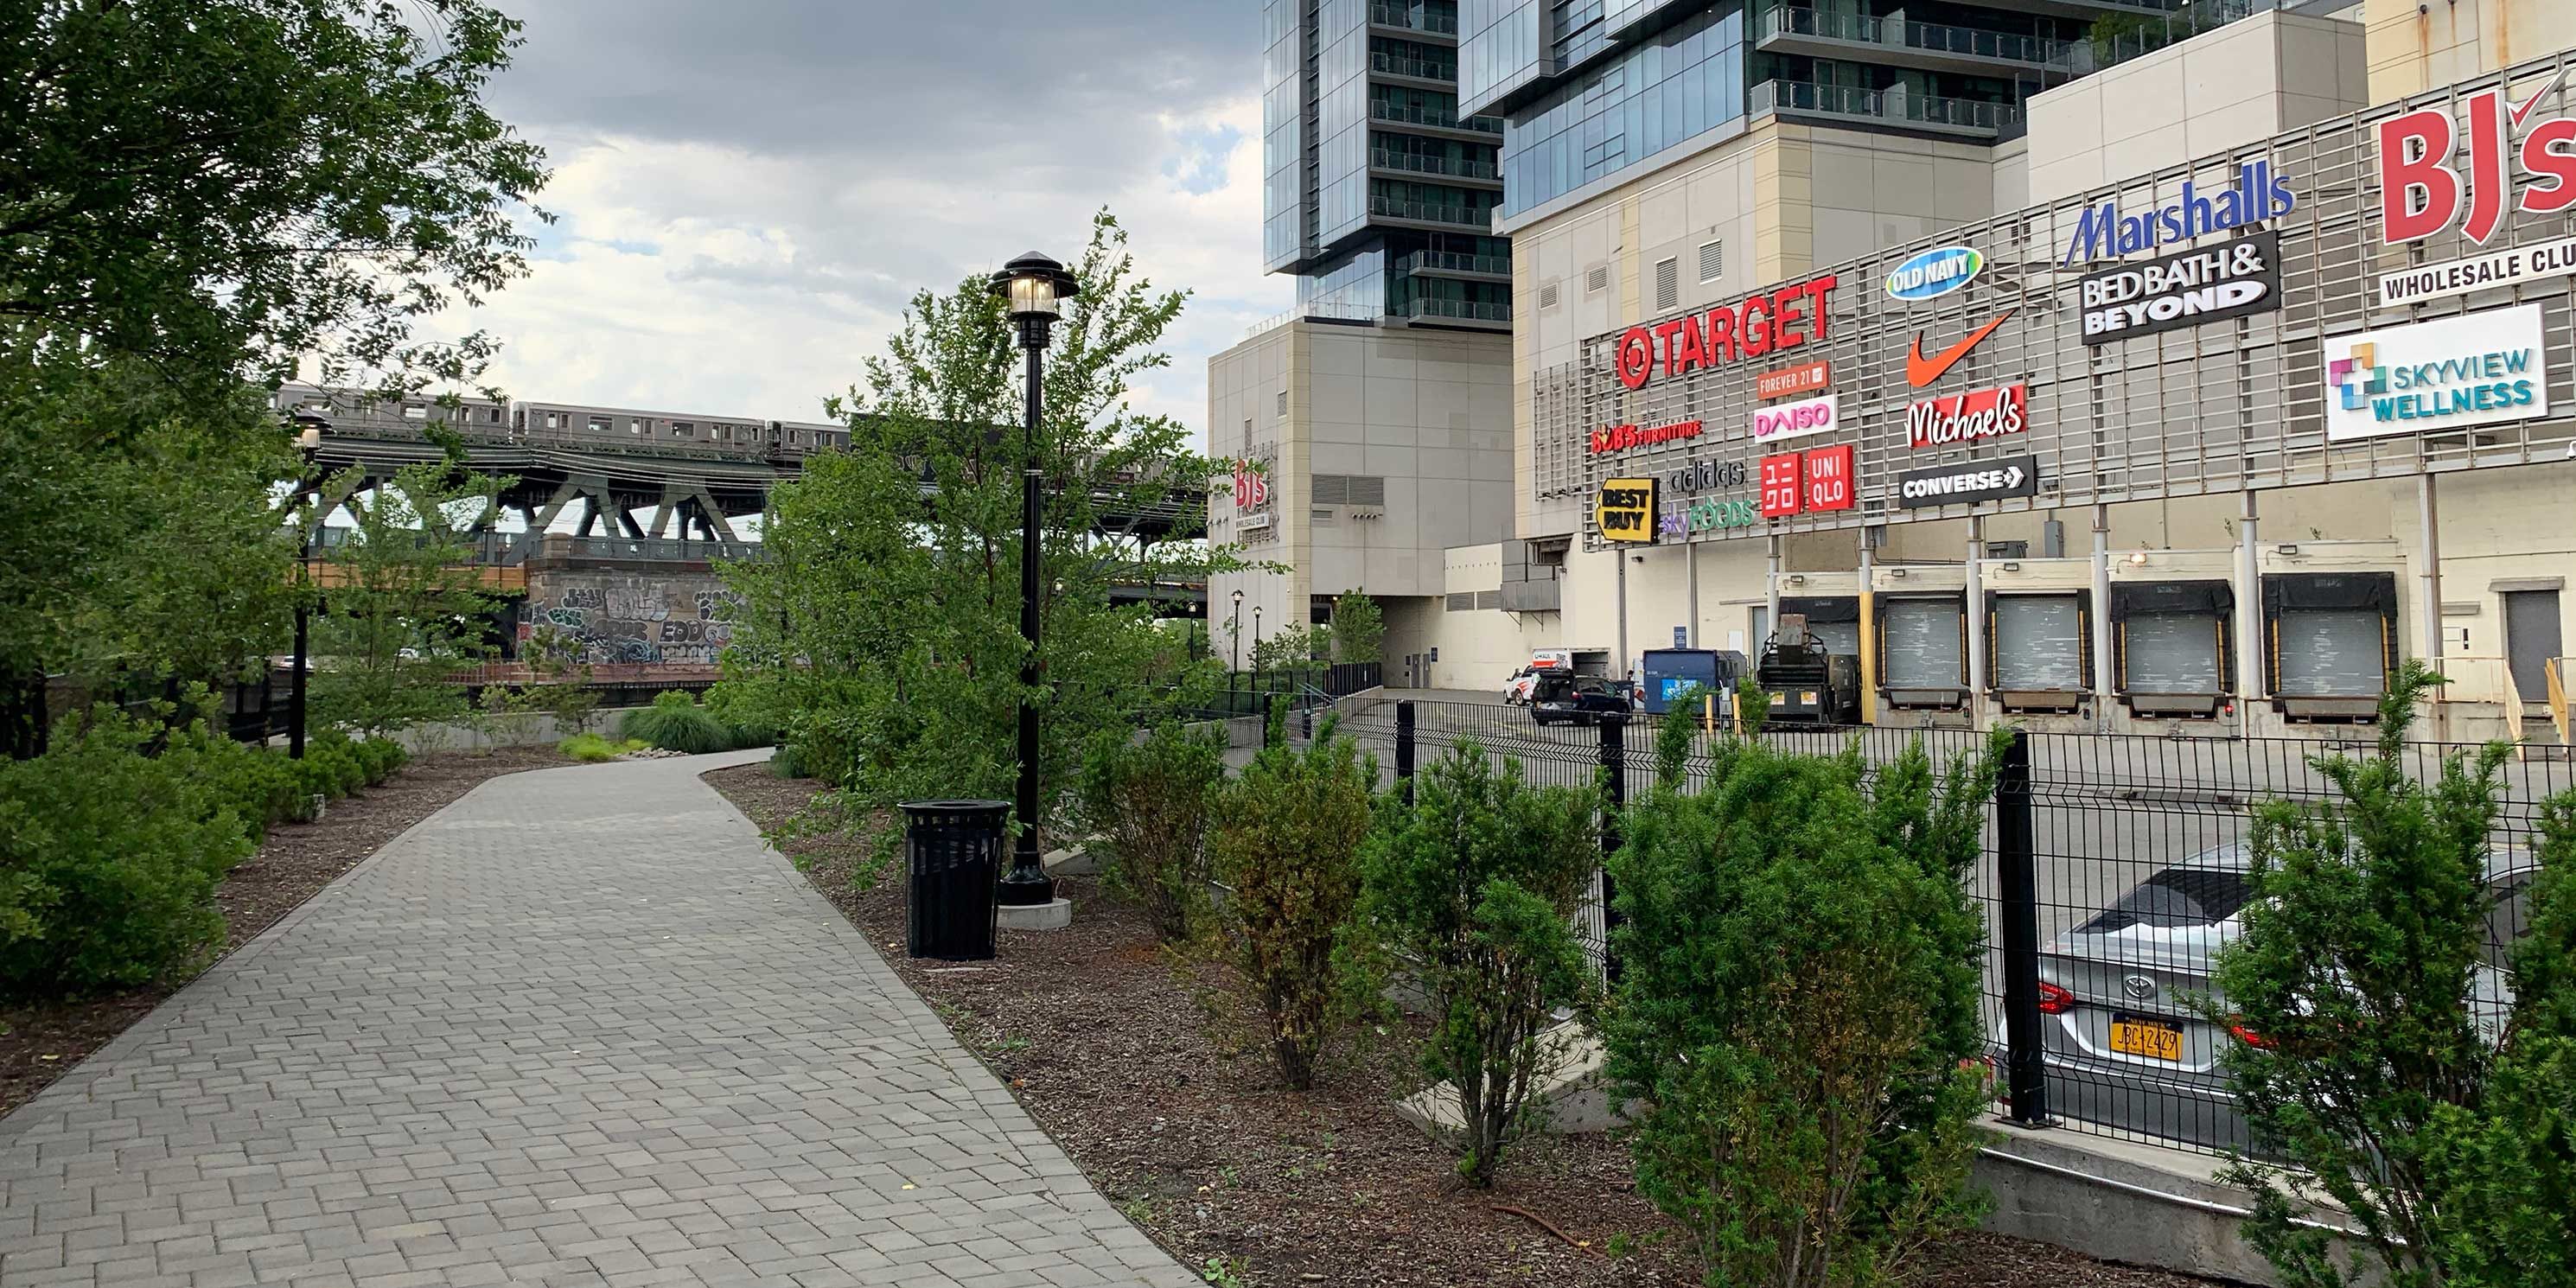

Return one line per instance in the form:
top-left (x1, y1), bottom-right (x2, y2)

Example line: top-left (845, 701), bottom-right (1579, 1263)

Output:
top-left (441, 0), bottom-right (1293, 430)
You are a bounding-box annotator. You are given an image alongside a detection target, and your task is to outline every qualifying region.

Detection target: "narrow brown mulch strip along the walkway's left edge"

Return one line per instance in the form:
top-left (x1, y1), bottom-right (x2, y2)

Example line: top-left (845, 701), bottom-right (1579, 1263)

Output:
top-left (0, 747), bottom-right (570, 1113)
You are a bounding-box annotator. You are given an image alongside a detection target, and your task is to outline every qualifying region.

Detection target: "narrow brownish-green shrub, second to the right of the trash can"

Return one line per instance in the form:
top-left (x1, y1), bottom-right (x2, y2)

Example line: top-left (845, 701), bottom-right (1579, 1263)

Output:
top-left (1211, 721), bottom-right (1378, 1090)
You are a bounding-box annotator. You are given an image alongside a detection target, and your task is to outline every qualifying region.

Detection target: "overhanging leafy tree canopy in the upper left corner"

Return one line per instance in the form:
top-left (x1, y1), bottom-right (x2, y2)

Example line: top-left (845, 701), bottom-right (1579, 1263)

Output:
top-left (0, 0), bottom-right (546, 391)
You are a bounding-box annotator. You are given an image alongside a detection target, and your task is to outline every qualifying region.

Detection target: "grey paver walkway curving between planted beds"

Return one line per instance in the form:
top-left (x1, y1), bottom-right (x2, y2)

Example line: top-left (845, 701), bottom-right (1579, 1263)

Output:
top-left (0, 752), bottom-right (1198, 1288)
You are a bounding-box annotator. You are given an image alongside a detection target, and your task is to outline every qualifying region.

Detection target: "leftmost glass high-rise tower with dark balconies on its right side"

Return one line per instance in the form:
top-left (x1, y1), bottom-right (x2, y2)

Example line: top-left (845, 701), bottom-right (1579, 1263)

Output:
top-left (1262, 0), bottom-right (1512, 329)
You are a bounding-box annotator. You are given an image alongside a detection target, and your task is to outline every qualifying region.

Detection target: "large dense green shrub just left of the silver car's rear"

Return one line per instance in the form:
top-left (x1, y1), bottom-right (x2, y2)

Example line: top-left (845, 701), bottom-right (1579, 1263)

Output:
top-left (1603, 739), bottom-right (1994, 1285)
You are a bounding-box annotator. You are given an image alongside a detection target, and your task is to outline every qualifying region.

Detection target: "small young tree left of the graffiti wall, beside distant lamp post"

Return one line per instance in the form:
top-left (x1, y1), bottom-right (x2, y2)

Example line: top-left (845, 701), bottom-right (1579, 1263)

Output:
top-left (312, 463), bottom-right (502, 734)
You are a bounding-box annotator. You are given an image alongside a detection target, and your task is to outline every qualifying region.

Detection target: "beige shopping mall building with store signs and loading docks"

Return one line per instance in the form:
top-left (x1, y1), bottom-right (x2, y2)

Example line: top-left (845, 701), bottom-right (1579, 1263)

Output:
top-left (1211, 0), bottom-right (2576, 736)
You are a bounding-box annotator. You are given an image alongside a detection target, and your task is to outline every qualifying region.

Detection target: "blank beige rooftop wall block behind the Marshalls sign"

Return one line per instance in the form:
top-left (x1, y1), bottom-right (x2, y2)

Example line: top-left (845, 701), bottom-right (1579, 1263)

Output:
top-left (2004, 0), bottom-right (2369, 208)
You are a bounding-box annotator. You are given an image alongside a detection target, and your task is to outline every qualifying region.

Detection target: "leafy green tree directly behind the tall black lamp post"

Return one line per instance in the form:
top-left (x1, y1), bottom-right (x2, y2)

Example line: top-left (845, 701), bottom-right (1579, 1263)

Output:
top-left (724, 214), bottom-right (1234, 817)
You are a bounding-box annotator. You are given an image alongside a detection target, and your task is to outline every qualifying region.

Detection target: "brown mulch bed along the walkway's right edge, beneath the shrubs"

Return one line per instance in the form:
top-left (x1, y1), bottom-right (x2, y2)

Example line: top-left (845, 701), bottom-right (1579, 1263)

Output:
top-left (706, 765), bottom-right (2235, 1288)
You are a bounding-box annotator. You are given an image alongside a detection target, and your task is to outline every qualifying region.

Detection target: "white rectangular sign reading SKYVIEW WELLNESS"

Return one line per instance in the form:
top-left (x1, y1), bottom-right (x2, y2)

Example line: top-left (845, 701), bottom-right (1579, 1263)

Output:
top-left (2326, 304), bottom-right (2550, 443)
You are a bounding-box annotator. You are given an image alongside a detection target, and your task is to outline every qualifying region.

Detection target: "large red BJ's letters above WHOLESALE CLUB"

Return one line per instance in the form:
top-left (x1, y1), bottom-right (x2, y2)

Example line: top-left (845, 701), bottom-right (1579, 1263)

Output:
top-left (2378, 72), bottom-right (2576, 245)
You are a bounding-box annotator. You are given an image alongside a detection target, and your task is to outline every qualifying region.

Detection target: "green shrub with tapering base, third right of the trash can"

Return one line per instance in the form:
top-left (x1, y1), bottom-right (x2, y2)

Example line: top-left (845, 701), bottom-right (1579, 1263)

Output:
top-left (1365, 739), bottom-right (1603, 1188)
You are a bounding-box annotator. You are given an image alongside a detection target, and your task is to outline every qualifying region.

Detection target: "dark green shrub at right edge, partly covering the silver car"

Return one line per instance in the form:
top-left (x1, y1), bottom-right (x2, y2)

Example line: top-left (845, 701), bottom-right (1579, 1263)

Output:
top-left (2205, 662), bottom-right (2576, 1288)
